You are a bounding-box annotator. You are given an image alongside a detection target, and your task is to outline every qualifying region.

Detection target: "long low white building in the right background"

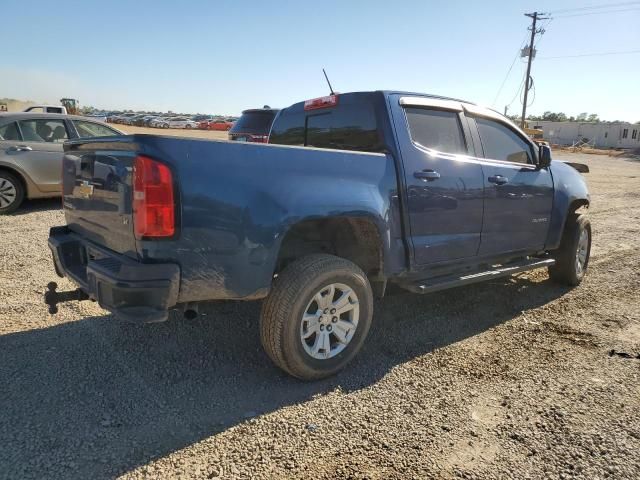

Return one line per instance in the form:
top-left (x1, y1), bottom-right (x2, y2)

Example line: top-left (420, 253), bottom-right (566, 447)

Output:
top-left (529, 121), bottom-right (640, 148)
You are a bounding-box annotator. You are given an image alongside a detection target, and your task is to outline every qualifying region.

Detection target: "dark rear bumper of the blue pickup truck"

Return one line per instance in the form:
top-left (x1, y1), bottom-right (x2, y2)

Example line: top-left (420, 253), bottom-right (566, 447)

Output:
top-left (49, 227), bottom-right (180, 323)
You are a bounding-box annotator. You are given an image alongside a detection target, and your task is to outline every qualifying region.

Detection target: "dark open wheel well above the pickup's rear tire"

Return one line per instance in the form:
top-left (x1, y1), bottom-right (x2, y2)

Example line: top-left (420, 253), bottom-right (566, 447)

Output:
top-left (276, 217), bottom-right (382, 278)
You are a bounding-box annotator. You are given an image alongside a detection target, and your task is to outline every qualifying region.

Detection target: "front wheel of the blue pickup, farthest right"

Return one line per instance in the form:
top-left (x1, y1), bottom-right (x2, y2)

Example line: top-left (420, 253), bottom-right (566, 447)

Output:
top-left (549, 214), bottom-right (591, 287)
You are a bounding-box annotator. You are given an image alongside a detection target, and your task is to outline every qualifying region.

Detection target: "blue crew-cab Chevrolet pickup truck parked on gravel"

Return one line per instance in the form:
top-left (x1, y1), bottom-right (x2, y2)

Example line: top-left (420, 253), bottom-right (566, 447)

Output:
top-left (45, 91), bottom-right (591, 380)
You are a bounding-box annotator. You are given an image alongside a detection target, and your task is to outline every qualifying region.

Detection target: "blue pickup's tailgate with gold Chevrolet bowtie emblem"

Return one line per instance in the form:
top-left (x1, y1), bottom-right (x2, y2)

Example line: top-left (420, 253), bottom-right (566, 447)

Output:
top-left (62, 137), bottom-right (137, 257)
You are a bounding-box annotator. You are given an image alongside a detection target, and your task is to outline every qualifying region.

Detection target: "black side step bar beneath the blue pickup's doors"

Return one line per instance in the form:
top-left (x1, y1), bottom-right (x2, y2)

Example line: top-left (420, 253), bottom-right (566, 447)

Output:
top-left (400, 258), bottom-right (556, 293)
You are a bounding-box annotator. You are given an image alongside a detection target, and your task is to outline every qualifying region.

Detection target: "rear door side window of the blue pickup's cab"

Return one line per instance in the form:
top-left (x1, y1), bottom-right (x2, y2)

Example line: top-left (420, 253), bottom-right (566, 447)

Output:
top-left (405, 107), bottom-right (467, 154)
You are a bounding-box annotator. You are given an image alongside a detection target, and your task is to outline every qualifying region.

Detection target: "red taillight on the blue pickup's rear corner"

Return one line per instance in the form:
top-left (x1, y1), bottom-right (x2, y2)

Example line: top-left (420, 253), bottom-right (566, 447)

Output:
top-left (133, 155), bottom-right (176, 239)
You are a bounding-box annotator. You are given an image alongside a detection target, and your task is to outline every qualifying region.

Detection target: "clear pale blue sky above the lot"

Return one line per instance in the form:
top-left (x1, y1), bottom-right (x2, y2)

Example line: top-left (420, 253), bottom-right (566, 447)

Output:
top-left (0, 0), bottom-right (640, 122)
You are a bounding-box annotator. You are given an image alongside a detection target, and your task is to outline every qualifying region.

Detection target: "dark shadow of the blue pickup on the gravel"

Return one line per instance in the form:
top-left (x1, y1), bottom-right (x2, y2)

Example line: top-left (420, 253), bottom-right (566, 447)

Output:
top-left (0, 272), bottom-right (566, 478)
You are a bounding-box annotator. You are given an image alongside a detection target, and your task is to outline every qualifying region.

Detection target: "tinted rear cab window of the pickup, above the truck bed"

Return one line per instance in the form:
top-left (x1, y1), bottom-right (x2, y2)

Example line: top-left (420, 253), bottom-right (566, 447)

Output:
top-left (269, 93), bottom-right (386, 152)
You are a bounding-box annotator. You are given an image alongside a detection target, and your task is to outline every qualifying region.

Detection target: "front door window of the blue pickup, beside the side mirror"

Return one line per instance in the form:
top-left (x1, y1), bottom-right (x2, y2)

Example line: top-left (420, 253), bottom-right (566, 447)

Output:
top-left (475, 117), bottom-right (533, 164)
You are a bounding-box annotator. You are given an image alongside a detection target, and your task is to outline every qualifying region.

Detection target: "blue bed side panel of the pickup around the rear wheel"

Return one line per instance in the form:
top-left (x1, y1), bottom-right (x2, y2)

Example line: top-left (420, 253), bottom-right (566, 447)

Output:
top-left (135, 135), bottom-right (404, 302)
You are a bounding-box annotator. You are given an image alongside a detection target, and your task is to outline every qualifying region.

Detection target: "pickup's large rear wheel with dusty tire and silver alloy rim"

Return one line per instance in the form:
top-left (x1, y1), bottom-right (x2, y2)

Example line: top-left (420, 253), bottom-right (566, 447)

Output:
top-left (260, 254), bottom-right (373, 380)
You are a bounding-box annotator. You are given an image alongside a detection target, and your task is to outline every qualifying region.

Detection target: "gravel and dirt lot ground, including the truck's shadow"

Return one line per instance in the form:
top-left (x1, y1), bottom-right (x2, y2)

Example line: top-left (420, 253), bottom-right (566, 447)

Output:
top-left (0, 154), bottom-right (640, 479)
